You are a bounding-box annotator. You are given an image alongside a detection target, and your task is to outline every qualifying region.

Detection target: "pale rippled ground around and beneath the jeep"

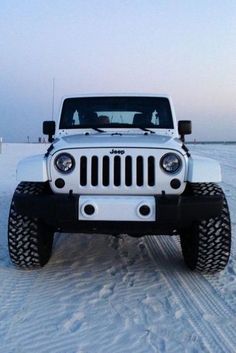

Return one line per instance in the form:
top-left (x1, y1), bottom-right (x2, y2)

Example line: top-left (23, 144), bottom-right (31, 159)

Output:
top-left (0, 144), bottom-right (236, 353)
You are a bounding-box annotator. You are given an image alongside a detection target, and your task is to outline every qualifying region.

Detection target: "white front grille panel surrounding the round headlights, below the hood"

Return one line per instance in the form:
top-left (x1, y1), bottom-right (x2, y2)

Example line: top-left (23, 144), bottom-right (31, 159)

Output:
top-left (50, 147), bottom-right (186, 196)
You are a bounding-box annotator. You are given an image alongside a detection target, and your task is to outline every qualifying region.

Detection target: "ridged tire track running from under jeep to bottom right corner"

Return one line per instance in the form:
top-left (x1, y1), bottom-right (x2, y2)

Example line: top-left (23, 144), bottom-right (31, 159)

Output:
top-left (145, 236), bottom-right (236, 353)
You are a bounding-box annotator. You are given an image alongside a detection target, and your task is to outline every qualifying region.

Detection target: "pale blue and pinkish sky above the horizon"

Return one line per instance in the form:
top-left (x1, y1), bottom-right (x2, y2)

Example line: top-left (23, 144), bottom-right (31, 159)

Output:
top-left (0, 0), bottom-right (236, 141)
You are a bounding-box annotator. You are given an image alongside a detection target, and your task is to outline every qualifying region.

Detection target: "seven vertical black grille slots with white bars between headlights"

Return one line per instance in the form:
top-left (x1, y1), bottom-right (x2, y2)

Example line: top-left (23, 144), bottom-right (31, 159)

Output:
top-left (79, 155), bottom-right (156, 187)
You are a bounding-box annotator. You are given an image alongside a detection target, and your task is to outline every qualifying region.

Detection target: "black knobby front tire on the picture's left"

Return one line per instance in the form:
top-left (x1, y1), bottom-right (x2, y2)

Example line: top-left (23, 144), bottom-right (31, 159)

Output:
top-left (8, 182), bottom-right (53, 269)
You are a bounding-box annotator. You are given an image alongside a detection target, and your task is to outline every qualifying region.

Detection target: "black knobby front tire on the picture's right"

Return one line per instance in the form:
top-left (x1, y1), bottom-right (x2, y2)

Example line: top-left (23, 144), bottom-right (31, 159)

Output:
top-left (180, 183), bottom-right (231, 273)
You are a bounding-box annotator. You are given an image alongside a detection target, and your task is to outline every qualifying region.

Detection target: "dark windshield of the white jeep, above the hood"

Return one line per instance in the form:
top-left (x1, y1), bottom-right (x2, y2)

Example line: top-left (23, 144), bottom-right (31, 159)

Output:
top-left (60, 97), bottom-right (173, 129)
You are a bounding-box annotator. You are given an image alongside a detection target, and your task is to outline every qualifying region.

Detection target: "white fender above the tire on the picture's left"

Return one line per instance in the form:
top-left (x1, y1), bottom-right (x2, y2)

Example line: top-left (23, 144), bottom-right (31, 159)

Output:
top-left (16, 154), bottom-right (48, 182)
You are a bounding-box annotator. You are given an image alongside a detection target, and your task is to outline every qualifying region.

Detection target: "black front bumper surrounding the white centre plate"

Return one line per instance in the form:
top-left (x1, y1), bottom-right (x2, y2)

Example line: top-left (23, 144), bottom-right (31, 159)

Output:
top-left (14, 194), bottom-right (223, 235)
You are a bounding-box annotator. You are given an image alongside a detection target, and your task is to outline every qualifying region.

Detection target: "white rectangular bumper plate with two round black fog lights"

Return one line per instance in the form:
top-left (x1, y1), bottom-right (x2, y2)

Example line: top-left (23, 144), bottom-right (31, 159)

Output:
top-left (78, 195), bottom-right (156, 222)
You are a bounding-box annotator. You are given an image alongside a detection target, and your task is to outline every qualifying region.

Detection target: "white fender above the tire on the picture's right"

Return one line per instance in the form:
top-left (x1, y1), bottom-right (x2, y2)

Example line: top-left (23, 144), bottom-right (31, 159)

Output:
top-left (187, 156), bottom-right (222, 183)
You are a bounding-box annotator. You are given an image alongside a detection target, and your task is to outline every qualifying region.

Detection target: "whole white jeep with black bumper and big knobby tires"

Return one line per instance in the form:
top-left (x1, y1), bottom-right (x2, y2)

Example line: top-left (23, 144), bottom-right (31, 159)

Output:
top-left (8, 95), bottom-right (231, 272)
